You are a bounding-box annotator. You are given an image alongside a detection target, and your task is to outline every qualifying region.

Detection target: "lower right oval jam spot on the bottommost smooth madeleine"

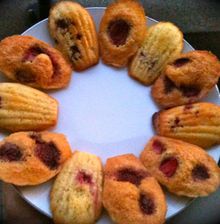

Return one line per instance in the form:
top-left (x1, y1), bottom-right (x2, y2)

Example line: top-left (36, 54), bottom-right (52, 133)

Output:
top-left (139, 194), bottom-right (155, 215)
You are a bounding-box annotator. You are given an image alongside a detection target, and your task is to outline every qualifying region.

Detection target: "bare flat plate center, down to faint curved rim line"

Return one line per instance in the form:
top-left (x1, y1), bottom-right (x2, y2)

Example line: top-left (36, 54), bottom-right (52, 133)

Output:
top-left (51, 63), bottom-right (157, 144)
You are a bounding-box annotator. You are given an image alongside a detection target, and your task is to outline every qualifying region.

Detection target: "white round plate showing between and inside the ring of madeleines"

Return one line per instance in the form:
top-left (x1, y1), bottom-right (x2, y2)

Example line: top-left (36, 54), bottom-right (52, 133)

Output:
top-left (0, 8), bottom-right (220, 224)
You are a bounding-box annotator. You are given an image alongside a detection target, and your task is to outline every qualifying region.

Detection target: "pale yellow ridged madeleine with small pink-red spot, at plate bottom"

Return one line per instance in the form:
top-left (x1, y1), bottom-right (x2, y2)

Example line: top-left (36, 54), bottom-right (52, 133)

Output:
top-left (50, 151), bottom-right (103, 224)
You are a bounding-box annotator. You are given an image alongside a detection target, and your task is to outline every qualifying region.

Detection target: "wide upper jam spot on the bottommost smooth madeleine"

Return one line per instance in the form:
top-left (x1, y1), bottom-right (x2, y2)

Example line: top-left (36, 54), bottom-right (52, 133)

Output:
top-left (116, 168), bottom-right (148, 186)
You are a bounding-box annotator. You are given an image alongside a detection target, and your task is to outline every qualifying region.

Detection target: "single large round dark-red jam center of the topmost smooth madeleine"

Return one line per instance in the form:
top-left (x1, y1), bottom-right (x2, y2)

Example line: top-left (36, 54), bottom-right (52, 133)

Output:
top-left (108, 19), bottom-right (131, 46)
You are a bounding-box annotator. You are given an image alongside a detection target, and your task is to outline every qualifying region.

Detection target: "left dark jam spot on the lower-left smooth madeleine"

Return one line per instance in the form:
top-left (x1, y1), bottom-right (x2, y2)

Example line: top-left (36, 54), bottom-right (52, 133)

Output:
top-left (0, 142), bottom-right (23, 162)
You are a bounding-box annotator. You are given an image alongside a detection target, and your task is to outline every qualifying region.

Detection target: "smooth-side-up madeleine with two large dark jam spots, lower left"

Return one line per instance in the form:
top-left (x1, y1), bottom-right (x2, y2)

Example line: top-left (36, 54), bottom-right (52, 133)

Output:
top-left (0, 132), bottom-right (71, 186)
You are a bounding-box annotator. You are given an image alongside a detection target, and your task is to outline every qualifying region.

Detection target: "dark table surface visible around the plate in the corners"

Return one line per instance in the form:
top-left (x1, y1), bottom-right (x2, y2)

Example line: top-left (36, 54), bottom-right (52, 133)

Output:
top-left (0, 0), bottom-right (220, 224)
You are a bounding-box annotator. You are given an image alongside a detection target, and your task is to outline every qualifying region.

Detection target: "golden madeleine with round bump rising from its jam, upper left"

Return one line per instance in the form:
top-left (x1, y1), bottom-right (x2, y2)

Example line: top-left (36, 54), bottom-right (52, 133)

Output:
top-left (0, 35), bottom-right (72, 89)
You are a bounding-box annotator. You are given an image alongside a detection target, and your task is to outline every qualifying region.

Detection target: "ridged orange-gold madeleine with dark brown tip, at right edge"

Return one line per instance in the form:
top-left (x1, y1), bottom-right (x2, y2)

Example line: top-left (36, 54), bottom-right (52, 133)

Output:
top-left (153, 102), bottom-right (220, 148)
